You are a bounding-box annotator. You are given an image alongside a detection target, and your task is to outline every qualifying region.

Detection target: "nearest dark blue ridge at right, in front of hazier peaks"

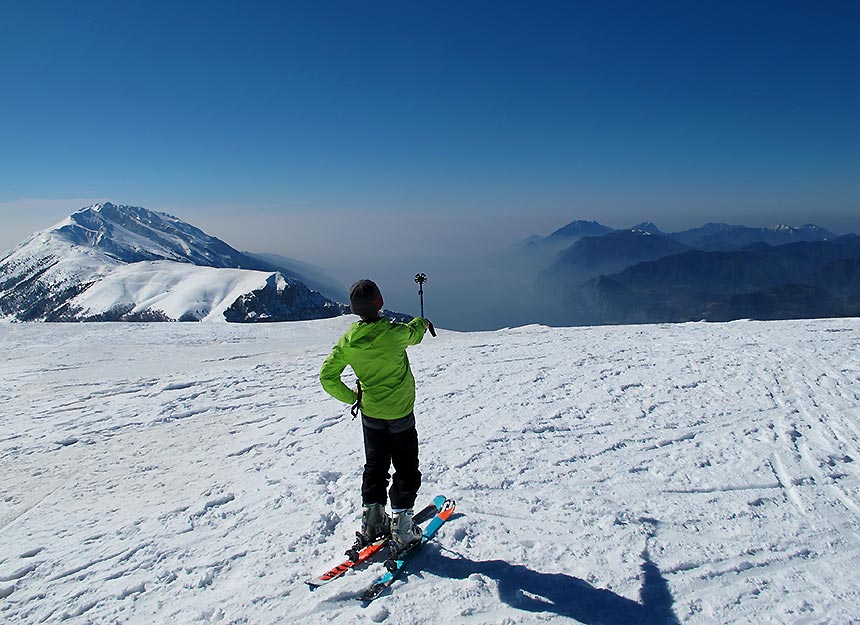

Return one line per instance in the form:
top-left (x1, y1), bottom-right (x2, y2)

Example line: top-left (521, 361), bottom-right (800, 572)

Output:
top-left (565, 235), bottom-right (860, 323)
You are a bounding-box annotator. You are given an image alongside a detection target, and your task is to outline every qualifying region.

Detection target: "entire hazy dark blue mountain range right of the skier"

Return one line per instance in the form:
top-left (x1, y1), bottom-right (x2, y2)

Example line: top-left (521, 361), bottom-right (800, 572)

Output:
top-left (532, 221), bottom-right (860, 325)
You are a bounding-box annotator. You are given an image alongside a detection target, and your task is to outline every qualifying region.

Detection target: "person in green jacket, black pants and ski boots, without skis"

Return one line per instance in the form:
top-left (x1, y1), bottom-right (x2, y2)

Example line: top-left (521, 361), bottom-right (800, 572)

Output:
top-left (320, 280), bottom-right (432, 553)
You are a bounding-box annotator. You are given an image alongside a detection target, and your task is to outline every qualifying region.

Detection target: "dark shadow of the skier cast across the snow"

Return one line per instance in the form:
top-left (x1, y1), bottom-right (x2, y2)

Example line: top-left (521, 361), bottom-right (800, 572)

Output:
top-left (421, 549), bottom-right (679, 625)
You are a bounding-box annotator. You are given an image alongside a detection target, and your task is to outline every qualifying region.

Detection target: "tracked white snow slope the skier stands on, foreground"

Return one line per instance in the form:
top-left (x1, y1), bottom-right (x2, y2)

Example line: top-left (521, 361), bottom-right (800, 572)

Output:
top-left (0, 318), bottom-right (860, 625)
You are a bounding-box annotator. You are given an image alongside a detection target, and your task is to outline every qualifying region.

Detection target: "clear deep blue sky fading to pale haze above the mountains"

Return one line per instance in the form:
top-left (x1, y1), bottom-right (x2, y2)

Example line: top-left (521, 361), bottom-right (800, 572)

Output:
top-left (0, 0), bottom-right (860, 269)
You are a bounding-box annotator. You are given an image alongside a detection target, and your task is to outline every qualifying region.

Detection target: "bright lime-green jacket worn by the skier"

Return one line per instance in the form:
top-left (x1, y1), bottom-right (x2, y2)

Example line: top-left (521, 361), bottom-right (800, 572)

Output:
top-left (320, 317), bottom-right (427, 419)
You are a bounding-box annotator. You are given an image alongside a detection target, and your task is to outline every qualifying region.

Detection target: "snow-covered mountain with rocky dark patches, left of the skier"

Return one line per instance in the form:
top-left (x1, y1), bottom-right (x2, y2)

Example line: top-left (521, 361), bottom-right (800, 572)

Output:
top-left (0, 202), bottom-right (344, 321)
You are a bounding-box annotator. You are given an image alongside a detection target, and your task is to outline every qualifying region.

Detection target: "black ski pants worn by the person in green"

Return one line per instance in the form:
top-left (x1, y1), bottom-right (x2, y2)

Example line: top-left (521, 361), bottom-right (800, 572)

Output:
top-left (361, 413), bottom-right (421, 508)
